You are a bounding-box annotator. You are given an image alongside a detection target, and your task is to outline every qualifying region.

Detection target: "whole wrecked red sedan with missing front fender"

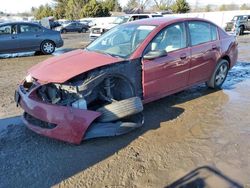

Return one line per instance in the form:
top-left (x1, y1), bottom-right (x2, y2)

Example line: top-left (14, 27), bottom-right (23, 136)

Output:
top-left (15, 18), bottom-right (238, 144)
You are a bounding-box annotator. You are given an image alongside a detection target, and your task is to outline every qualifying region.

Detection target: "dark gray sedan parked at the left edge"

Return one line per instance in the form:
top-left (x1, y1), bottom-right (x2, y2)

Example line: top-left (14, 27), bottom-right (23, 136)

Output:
top-left (0, 22), bottom-right (63, 54)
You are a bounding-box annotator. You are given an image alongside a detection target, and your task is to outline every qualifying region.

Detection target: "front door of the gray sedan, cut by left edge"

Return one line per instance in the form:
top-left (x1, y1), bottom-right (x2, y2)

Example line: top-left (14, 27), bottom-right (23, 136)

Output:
top-left (0, 24), bottom-right (20, 53)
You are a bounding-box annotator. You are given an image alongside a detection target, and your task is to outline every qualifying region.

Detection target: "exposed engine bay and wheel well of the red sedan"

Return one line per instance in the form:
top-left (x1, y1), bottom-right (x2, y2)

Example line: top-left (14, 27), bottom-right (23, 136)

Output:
top-left (37, 60), bottom-right (142, 110)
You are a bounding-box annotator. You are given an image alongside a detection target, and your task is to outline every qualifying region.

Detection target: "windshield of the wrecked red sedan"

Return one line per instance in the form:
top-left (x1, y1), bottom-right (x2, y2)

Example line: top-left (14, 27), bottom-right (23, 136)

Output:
top-left (86, 24), bottom-right (155, 58)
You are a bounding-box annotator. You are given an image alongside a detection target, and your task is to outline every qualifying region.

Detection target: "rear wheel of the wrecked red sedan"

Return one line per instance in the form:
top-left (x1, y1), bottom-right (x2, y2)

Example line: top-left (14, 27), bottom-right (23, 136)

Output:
top-left (206, 59), bottom-right (229, 89)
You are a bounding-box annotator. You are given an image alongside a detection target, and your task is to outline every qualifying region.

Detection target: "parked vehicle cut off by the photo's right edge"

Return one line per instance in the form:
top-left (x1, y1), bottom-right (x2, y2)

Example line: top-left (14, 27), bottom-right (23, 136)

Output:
top-left (225, 15), bottom-right (250, 35)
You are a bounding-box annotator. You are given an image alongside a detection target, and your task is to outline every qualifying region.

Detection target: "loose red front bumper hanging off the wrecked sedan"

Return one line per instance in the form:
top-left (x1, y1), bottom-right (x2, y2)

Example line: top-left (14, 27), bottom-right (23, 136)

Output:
top-left (15, 85), bottom-right (101, 144)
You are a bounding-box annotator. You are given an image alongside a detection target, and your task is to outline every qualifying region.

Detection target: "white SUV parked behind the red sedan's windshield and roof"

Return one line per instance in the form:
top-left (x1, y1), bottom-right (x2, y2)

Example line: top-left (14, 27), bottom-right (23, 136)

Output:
top-left (89, 14), bottom-right (163, 40)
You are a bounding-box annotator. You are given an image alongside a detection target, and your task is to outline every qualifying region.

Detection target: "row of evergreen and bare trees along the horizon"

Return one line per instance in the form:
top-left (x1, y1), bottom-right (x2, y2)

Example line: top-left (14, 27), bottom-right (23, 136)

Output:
top-left (31, 0), bottom-right (190, 20)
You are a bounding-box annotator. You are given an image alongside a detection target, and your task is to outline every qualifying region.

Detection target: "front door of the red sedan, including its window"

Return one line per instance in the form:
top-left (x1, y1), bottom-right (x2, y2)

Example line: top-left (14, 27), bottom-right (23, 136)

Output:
top-left (143, 23), bottom-right (190, 101)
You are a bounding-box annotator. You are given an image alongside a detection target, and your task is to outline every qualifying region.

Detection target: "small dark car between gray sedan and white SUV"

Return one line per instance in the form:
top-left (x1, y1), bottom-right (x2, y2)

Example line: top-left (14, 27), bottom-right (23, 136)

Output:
top-left (55, 22), bottom-right (89, 33)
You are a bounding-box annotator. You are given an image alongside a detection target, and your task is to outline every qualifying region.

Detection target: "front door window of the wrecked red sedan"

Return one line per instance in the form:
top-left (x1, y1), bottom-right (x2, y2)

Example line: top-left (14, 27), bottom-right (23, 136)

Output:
top-left (149, 23), bottom-right (187, 52)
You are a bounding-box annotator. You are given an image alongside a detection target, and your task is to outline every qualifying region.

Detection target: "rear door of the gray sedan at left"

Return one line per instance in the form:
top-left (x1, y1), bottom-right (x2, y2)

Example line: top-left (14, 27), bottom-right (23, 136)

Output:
top-left (18, 23), bottom-right (43, 50)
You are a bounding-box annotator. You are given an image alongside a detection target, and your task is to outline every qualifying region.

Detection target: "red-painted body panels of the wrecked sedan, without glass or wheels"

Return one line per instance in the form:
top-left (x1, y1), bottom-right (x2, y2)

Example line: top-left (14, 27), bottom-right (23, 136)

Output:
top-left (16, 17), bottom-right (238, 144)
